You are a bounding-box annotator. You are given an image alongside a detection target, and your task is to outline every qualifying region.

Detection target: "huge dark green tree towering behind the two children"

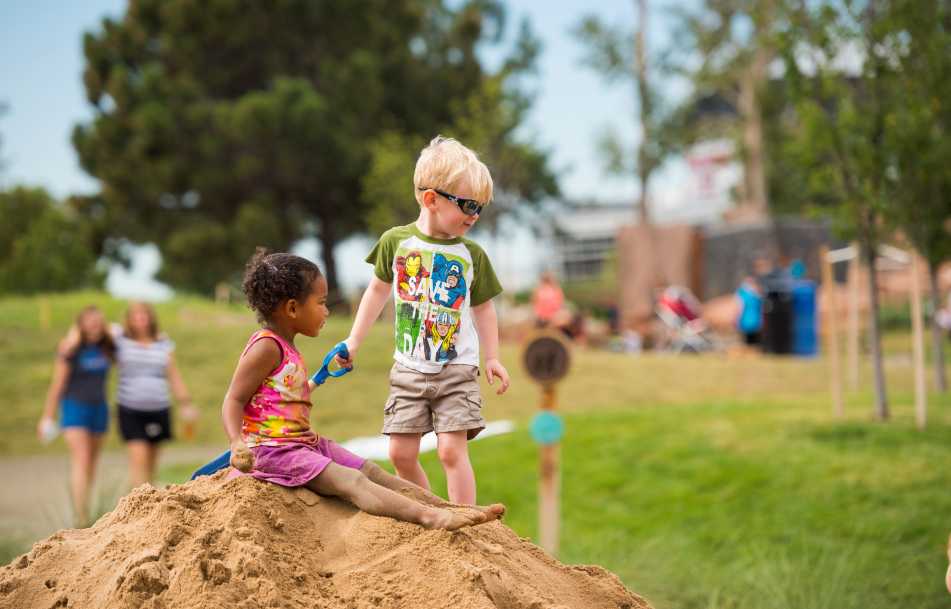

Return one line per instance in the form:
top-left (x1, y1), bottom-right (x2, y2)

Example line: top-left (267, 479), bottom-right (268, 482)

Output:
top-left (73, 0), bottom-right (552, 292)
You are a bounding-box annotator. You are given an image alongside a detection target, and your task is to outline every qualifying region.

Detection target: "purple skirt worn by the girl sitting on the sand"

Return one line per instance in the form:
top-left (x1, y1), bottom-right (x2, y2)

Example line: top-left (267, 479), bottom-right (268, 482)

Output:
top-left (227, 436), bottom-right (366, 487)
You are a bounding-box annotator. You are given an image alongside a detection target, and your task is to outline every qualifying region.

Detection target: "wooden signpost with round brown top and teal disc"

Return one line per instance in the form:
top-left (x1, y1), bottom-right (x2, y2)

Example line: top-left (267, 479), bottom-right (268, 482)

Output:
top-left (522, 331), bottom-right (571, 555)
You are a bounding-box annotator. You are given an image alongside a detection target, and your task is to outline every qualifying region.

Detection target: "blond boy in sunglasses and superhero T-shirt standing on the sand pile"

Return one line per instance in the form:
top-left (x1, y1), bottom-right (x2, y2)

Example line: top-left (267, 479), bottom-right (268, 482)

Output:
top-left (341, 137), bottom-right (509, 504)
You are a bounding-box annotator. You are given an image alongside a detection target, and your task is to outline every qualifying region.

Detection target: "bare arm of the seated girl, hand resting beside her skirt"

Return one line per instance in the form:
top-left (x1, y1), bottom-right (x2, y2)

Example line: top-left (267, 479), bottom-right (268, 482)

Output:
top-left (221, 339), bottom-right (281, 472)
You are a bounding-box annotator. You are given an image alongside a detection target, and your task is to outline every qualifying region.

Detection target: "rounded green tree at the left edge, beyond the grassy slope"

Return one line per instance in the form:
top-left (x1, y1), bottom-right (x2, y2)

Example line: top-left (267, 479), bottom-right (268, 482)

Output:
top-left (0, 187), bottom-right (104, 294)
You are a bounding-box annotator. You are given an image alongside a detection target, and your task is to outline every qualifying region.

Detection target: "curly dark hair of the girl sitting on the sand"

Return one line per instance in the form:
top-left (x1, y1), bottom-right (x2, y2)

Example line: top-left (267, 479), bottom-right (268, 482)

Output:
top-left (241, 247), bottom-right (321, 323)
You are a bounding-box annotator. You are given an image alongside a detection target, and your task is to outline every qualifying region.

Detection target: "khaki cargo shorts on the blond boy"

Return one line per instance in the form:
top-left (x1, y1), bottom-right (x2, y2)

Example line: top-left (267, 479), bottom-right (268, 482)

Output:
top-left (383, 363), bottom-right (485, 440)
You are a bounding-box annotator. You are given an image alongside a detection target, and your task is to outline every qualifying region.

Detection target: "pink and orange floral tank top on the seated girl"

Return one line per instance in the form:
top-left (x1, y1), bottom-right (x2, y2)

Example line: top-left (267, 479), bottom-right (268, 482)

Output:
top-left (241, 329), bottom-right (317, 447)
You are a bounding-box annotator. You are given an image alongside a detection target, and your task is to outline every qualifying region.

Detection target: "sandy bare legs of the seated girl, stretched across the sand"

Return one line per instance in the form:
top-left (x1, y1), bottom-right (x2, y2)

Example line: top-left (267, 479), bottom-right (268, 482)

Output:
top-left (307, 463), bottom-right (504, 531)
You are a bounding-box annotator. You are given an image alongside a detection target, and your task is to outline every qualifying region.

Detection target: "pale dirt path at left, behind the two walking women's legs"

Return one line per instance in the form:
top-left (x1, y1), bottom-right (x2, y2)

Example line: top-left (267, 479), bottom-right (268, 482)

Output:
top-left (0, 446), bottom-right (222, 543)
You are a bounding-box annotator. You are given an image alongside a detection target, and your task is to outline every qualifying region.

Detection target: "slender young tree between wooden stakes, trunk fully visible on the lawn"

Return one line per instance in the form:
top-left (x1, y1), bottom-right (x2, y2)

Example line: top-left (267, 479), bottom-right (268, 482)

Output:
top-left (782, 0), bottom-right (904, 420)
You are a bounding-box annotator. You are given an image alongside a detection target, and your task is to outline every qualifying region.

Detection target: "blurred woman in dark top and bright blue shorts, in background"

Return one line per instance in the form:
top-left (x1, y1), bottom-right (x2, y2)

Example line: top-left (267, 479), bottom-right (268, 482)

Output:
top-left (37, 306), bottom-right (116, 526)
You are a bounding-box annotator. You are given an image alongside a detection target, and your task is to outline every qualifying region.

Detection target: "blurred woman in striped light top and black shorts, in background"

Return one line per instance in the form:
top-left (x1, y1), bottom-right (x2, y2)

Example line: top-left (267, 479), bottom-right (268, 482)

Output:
top-left (112, 302), bottom-right (197, 488)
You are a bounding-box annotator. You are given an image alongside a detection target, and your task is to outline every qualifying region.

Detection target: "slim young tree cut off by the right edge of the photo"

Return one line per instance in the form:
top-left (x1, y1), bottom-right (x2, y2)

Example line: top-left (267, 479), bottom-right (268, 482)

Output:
top-left (887, 0), bottom-right (951, 392)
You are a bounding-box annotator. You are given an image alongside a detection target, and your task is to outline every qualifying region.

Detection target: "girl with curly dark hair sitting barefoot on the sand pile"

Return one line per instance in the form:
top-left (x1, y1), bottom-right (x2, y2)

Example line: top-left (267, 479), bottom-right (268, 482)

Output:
top-left (221, 248), bottom-right (505, 530)
